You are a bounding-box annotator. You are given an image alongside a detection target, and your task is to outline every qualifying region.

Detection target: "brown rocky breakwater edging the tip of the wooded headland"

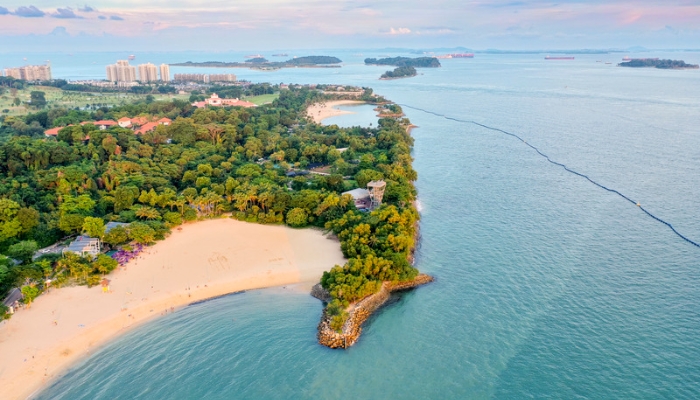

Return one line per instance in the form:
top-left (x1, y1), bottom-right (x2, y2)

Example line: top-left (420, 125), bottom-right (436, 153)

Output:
top-left (311, 274), bottom-right (433, 349)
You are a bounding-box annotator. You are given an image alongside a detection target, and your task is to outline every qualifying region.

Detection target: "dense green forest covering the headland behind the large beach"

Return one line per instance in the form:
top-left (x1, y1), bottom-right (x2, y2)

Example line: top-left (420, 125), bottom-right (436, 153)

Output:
top-left (0, 86), bottom-right (418, 328)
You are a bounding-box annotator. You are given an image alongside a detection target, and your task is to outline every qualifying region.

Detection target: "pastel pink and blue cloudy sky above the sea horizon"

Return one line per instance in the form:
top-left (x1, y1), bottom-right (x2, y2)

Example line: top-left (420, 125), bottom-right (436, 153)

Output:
top-left (0, 0), bottom-right (700, 52)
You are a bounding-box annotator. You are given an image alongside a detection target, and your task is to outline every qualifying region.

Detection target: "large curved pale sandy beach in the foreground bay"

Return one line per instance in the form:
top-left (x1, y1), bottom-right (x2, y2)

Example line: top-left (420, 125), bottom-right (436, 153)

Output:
top-left (0, 219), bottom-right (344, 399)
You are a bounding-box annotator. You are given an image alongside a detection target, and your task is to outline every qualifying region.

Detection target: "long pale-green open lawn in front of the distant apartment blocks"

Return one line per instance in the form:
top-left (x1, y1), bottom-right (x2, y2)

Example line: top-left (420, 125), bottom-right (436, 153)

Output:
top-left (0, 86), bottom-right (189, 115)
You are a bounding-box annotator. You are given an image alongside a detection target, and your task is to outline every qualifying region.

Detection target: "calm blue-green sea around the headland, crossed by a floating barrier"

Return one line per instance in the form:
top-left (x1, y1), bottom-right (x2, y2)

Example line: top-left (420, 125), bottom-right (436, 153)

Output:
top-left (10, 52), bottom-right (700, 399)
